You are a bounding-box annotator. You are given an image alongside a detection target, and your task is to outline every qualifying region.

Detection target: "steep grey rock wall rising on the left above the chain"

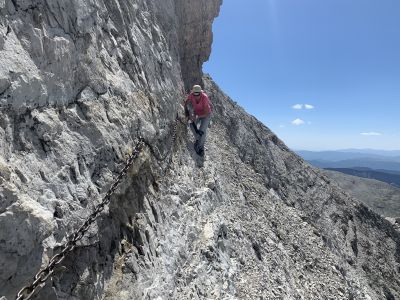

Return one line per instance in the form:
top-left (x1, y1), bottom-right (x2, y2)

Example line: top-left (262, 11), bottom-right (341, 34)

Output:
top-left (0, 0), bottom-right (220, 298)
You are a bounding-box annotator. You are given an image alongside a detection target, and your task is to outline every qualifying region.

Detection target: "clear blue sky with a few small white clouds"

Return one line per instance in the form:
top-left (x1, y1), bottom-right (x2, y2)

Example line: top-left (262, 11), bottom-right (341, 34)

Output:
top-left (203, 0), bottom-right (400, 150)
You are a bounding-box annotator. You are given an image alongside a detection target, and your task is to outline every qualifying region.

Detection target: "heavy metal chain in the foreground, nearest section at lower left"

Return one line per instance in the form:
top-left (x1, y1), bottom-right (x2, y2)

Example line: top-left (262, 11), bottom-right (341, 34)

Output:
top-left (16, 137), bottom-right (145, 300)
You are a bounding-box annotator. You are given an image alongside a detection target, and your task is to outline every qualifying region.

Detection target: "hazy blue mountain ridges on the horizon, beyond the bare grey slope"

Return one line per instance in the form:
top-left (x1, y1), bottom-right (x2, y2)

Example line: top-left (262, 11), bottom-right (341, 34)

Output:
top-left (296, 149), bottom-right (400, 186)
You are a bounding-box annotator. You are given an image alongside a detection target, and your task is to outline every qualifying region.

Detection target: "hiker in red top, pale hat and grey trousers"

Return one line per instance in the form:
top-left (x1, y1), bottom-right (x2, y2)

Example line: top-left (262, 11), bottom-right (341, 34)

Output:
top-left (185, 85), bottom-right (211, 156)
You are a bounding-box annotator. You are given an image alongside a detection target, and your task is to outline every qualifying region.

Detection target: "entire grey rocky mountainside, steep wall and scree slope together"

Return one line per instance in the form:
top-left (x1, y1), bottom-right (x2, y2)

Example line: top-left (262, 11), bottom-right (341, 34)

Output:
top-left (0, 0), bottom-right (400, 299)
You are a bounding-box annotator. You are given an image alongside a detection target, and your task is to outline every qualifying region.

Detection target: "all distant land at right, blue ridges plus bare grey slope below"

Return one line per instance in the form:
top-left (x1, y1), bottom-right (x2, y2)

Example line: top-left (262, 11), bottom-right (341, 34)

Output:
top-left (296, 149), bottom-right (400, 218)
